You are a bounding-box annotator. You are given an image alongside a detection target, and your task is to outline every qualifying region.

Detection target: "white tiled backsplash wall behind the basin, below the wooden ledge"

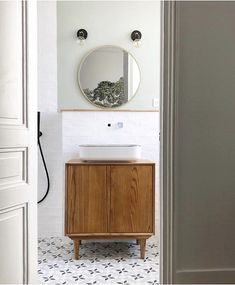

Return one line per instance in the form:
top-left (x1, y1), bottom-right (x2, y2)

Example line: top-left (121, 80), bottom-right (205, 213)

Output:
top-left (62, 112), bottom-right (159, 237)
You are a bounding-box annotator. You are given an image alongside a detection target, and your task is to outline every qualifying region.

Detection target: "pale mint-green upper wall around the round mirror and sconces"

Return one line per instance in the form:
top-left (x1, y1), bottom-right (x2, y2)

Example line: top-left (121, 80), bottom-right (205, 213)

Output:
top-left (57, 1), bottom-right (160, 110)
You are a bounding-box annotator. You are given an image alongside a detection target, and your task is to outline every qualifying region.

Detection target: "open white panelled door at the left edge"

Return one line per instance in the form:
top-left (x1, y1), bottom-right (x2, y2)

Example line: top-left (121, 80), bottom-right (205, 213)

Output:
top-left (0, 1), bottom-right (37, 284)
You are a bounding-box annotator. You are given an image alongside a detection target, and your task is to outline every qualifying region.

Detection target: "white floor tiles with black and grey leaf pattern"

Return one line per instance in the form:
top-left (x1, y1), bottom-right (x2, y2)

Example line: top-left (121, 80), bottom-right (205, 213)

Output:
top-left (38, 237), bottom-right (159, 285)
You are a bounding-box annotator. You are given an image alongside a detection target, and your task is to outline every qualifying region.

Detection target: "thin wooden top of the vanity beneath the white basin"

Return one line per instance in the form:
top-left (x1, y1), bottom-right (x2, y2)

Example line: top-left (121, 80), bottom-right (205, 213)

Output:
top-left (66, 159), bottom-right (155, 165)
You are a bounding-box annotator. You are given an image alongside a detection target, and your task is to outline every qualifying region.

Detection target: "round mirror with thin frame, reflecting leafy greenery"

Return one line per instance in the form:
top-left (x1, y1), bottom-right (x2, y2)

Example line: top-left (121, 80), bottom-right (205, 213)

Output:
top-left (78, 46), bottom-right (140, 108)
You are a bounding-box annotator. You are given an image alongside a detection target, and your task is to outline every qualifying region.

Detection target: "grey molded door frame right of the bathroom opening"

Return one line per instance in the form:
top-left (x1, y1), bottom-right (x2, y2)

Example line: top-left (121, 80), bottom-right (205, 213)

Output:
top-left (160, 0), bottom-right (176, 284)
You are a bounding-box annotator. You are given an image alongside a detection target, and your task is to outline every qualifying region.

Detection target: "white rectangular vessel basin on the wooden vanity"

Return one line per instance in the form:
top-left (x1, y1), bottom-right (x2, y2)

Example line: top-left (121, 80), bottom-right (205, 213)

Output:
top-left (79, 144), bottom-right (141, 161)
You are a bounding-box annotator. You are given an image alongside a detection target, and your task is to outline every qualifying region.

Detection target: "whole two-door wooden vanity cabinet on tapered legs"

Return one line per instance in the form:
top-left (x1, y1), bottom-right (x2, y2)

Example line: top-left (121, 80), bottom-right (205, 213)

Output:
top-left (65, 160), bottom-right (155, 259)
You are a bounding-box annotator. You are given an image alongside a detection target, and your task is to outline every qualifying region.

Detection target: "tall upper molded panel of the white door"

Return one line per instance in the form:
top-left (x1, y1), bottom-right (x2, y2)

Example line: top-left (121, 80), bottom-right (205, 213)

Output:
top-left (0, 1), bottom-right (27, 128)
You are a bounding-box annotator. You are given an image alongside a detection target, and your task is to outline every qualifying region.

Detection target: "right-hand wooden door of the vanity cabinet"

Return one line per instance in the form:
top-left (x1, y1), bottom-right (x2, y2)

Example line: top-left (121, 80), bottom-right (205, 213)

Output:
top-left (110, 165), bottom-right (154, 233)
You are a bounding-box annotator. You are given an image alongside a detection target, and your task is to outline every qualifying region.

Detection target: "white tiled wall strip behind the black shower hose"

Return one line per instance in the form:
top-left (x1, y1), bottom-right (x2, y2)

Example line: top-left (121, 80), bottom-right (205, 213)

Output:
top-left (38, 1), bottom-right (63, 236)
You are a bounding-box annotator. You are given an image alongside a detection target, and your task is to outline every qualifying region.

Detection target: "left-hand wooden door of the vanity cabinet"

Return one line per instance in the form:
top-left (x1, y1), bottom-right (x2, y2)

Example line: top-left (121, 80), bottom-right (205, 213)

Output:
top-left (66, 165), bottom-right (109, 234)
